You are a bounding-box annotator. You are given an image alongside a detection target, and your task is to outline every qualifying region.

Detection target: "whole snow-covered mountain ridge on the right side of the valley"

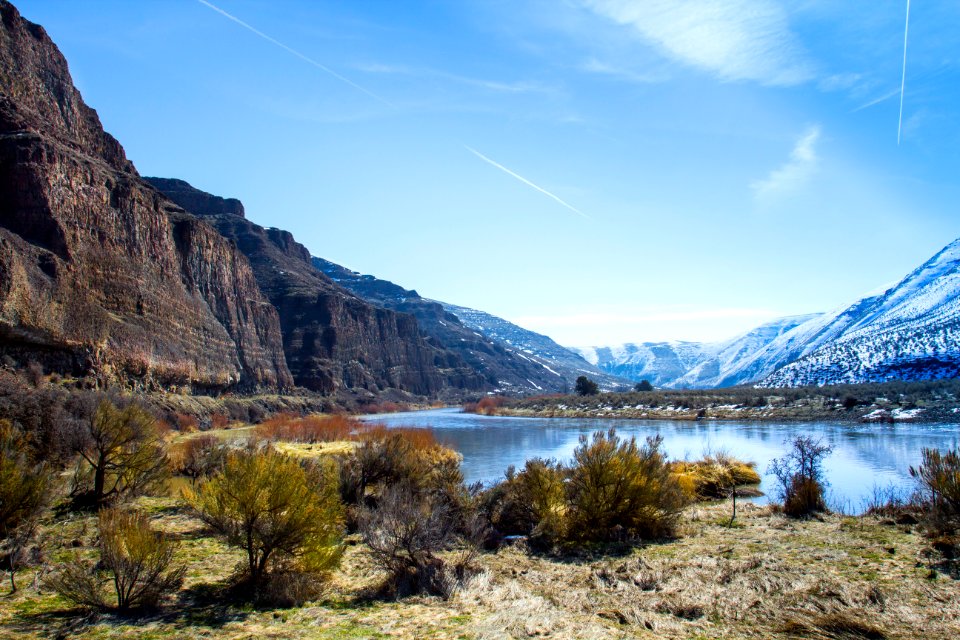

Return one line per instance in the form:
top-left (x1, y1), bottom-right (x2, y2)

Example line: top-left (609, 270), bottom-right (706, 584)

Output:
top-left (577, 240), bottom-right (960, 388)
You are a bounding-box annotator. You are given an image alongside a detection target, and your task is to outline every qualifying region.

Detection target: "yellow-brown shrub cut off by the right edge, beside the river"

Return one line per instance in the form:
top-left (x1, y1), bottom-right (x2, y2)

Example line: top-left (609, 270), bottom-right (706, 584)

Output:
top-left (910, 448), bottom-right (960, 533)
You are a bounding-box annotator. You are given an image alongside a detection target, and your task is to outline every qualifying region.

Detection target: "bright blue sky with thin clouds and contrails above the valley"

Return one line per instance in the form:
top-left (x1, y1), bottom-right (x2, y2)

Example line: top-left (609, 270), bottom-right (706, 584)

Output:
top-left (17, 0), bottom-right (960, 345)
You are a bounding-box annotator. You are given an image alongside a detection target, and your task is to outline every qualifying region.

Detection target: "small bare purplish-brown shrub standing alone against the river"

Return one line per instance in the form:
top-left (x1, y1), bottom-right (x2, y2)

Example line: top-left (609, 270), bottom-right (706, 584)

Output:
top-left (769, 436), bottom-right (832, 518)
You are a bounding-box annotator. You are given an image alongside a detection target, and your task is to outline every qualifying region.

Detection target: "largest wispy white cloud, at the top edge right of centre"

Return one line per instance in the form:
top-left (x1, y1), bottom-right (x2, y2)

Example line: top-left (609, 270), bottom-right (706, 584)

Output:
top-left (581, 0), bottom-right (813, 85)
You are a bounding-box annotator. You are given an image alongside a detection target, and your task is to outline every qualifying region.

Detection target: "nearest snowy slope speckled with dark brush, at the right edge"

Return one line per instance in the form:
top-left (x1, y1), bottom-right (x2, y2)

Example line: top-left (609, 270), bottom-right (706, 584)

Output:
top-left (762, 240), bottom-right (960, 387)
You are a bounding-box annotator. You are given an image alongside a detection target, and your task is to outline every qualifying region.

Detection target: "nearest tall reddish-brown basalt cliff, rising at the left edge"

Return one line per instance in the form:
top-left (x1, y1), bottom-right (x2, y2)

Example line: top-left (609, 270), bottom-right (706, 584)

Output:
top-left (0, 0), bottom-right (293, 390)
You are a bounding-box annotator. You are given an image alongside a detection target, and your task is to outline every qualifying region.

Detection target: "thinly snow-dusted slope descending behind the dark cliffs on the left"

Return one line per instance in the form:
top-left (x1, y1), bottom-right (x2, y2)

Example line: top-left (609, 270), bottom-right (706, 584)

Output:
top-left (439, 302), bottom-right (631, 390)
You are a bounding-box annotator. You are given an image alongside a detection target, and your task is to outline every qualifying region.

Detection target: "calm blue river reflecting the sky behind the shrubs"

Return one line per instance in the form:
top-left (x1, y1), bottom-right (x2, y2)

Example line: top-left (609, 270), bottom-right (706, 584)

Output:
top-left (363, 409), bottom-right (960, 512)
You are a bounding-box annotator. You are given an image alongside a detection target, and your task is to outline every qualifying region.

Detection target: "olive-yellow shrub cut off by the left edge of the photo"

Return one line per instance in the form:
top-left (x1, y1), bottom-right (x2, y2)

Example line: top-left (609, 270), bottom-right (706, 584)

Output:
top-left (0, 420), bottom-right (53, 593)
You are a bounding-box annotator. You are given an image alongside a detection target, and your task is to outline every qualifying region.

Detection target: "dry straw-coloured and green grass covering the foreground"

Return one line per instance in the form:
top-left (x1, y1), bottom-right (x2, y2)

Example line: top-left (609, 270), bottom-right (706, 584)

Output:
top-left (0, 498), bottom-right (960, 640)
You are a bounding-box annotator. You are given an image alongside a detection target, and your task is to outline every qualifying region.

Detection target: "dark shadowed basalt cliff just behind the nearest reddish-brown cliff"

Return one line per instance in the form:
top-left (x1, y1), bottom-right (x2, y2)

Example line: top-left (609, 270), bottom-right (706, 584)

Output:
top-left (146, 178), bottom-right (491, 396)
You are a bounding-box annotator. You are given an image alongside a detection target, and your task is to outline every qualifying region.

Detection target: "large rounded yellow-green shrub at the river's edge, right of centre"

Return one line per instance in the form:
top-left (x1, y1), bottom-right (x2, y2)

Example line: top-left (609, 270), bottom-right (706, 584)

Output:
top-left (567, 429), bottom-right (687, 541)
